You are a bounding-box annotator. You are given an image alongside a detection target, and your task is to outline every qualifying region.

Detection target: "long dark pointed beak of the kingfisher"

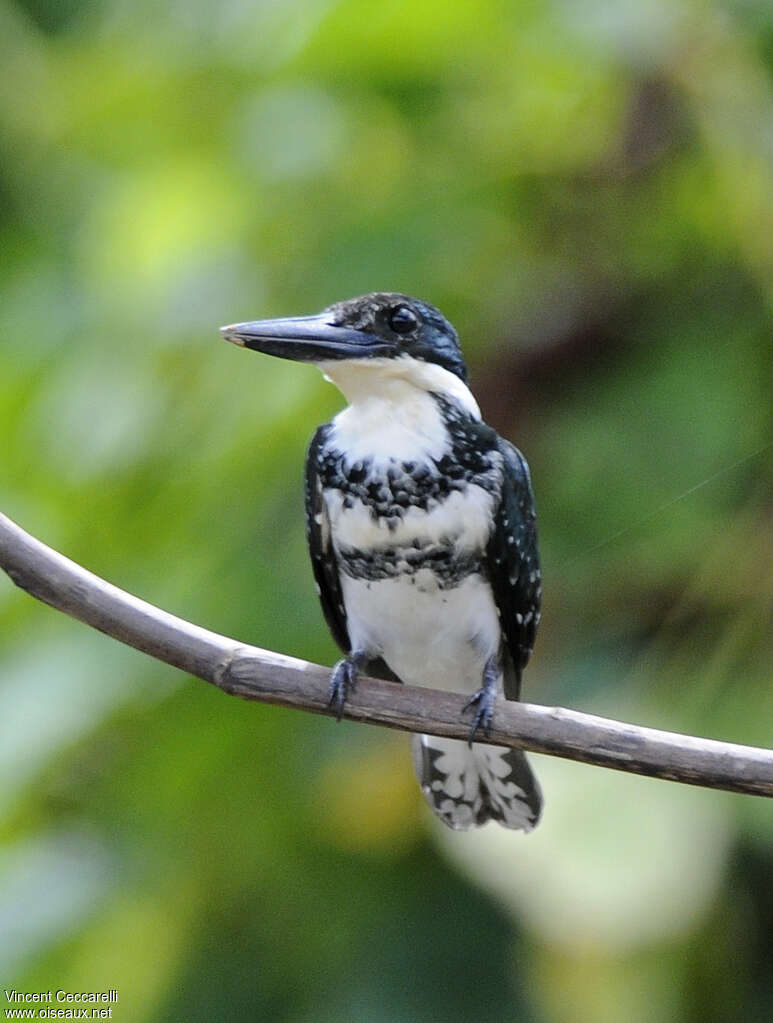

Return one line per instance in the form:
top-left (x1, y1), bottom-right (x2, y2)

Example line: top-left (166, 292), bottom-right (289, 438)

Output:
top-left (220, 313), bottom-right (392, 362)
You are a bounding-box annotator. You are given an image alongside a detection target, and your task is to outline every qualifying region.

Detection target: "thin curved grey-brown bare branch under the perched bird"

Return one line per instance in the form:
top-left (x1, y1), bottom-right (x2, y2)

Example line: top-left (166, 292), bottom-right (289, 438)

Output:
top-left (0, 515), bottom-right (773, 796)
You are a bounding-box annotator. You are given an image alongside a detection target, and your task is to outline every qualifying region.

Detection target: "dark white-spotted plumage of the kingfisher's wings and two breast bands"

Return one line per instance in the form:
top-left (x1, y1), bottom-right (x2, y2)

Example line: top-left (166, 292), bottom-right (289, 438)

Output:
top-left (306, 394), bottom-right (542, 700)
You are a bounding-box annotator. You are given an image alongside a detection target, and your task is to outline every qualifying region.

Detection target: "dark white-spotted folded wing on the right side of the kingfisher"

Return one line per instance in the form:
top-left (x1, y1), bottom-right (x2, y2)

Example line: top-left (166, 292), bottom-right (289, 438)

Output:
top-left (487, 437), bottom-right (542, 700)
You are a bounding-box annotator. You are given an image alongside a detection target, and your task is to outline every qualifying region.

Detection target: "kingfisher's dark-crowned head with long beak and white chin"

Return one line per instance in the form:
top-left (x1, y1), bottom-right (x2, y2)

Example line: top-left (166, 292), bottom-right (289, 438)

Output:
top-left (221, 292), bottom-right (467, 398)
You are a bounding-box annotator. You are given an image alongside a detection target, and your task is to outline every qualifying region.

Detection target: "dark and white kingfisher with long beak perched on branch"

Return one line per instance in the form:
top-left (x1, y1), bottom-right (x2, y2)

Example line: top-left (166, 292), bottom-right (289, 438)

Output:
top-left (221, 292), bottom-right (542, 832)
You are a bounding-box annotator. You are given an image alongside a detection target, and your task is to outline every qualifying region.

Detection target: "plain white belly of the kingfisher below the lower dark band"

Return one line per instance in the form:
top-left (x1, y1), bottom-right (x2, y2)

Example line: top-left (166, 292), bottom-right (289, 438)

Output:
top-left (342, 570), bottom-right (500, 694)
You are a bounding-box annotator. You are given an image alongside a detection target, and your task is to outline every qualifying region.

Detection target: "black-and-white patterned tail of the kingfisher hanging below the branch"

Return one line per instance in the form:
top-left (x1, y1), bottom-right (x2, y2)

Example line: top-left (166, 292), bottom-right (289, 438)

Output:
top-left (413, 736), bottom-right (542, 832)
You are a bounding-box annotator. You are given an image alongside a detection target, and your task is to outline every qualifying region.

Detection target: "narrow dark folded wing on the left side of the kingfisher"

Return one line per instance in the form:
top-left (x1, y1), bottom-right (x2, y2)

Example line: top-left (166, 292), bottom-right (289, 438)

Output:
top-left (306, 424), bottom-right (350, 654)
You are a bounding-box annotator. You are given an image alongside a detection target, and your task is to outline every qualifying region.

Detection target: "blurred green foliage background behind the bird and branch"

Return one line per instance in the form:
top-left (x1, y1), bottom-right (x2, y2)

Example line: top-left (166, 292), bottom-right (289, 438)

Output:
top-left (0, 0), bottom-right (773, 1023)
